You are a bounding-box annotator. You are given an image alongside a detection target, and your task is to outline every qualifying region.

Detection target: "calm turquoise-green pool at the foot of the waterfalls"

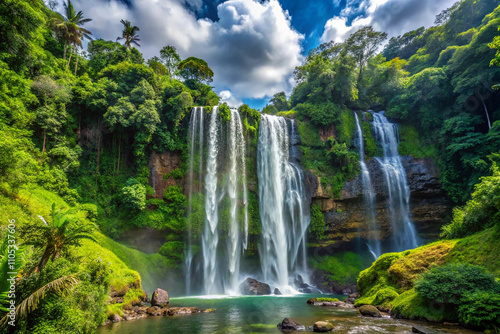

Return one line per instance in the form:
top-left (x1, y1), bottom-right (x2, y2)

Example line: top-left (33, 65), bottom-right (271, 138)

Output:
top-left (98, 295), bottom-right (478, 334)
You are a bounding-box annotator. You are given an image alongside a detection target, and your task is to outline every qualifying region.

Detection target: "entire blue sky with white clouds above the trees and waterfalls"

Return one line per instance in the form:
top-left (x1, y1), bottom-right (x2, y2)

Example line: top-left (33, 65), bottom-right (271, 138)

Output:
top-left (56, 0), bottom-right (456, 109)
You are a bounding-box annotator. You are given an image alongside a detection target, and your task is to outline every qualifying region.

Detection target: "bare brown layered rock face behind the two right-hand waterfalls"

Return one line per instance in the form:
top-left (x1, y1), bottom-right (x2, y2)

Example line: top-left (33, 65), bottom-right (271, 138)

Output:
top-left (306, 157), bottom-right (452, 245)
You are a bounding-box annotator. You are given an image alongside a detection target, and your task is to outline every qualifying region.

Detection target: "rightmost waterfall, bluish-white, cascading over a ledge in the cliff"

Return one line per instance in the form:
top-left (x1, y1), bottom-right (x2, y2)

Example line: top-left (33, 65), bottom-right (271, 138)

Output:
top-left (373, 112), bottom-right (418, 251)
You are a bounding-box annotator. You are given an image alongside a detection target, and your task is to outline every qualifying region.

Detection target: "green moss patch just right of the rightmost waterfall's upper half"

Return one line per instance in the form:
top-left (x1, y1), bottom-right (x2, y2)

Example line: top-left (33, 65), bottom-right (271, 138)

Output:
top-left (399, 124), bottom-right (439, 158)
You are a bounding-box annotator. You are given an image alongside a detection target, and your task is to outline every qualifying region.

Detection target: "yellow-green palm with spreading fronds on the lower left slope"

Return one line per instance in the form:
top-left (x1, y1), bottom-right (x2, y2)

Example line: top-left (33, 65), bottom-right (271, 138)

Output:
top-left (23, 203), bottom-right (96, 273)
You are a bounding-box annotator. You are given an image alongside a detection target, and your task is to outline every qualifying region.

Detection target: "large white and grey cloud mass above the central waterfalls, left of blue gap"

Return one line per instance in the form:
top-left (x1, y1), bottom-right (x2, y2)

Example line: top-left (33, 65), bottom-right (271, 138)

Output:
top-left (60, 0), bottom-right (303, 102)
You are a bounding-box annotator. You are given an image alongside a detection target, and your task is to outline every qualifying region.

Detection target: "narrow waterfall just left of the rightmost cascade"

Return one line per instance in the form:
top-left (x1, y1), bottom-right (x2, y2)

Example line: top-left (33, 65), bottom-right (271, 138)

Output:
top-left (354, 112), bottom-right (382, 260)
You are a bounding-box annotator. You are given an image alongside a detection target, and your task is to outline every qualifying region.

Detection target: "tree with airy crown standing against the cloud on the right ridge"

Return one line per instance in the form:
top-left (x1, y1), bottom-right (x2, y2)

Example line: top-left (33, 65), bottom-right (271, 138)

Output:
top-left (346, 27), bottom-right (387, 82)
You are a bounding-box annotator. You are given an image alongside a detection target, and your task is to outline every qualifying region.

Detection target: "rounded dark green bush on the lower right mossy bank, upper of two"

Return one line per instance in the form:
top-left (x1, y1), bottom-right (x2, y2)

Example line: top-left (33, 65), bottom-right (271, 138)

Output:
top-left (415, 263), bottom-right (496, 305)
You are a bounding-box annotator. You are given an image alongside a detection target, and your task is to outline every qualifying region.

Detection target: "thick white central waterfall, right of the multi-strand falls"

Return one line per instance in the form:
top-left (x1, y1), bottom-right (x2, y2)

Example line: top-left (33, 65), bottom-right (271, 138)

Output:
top-left (257, 115), bottom-right (310, 292)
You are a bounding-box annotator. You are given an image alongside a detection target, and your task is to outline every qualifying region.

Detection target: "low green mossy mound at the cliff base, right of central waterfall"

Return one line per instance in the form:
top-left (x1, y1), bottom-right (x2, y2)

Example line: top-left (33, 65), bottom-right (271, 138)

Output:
top-left (311, 252), bottom-right (369, 284)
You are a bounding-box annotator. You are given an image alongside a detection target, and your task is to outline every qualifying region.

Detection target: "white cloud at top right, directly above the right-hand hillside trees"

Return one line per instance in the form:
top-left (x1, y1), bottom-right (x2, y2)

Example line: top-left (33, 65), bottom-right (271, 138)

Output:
top-left (321, 0), bottom-right (456, 42)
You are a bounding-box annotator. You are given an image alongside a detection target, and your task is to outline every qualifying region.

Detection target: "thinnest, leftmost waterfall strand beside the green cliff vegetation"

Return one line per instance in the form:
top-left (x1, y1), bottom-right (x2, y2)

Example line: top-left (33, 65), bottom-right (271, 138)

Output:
top-left (185, 107), bottom-right (204, 295)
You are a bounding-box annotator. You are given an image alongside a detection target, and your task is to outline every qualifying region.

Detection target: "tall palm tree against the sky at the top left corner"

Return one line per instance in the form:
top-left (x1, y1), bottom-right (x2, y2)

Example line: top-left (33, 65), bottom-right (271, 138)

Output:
top-left (54, 0), bottom-right (92, 74)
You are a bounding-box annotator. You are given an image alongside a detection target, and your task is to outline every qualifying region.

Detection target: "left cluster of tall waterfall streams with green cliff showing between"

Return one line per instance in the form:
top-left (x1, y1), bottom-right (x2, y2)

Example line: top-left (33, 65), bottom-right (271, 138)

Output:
top-left (185, 107), bottom-right (248, 294)
